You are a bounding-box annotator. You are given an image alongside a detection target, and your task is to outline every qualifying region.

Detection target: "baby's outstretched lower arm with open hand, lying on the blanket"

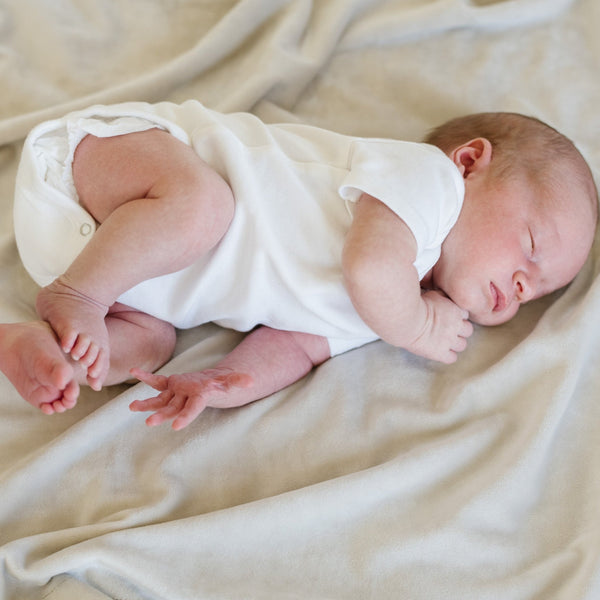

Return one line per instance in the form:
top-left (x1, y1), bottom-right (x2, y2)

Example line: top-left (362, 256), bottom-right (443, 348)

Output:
top-left (130, 327), bottom-right (330, 430)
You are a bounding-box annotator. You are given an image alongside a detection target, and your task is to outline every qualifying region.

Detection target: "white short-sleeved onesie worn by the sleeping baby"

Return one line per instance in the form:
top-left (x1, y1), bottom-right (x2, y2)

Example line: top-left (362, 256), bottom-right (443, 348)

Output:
top-left (14, 100), bottom-right (464, 355)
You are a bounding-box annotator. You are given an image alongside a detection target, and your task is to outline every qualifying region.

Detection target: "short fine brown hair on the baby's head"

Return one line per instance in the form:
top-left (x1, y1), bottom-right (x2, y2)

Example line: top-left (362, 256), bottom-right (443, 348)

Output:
top-left (424, 112), bottom-right (598, 214)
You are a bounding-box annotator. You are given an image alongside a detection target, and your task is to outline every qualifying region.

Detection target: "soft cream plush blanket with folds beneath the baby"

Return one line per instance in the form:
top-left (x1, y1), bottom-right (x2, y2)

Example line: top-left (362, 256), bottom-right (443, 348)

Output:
top-left (0, 0), bottom-right (600, 600)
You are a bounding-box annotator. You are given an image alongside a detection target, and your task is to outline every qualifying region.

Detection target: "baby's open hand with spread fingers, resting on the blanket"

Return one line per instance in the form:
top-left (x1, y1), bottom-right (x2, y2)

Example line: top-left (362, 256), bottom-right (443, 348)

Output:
top-left (129, 368), bottom-right (252, 430)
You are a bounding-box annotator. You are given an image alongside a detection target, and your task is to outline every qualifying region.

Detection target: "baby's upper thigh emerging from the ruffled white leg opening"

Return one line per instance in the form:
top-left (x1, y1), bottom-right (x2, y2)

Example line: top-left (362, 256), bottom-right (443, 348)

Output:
top-left (73, 129), bottom-right (228, 223)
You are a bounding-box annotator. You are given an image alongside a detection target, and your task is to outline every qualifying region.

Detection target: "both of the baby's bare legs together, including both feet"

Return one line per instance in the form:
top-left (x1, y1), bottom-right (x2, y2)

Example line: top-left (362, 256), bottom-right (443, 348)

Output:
top-left (0, 130), bottom-right (233, 412)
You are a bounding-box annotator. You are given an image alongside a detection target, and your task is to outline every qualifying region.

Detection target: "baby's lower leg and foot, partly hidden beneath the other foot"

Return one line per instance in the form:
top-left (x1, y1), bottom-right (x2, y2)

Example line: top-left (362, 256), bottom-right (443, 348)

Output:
top-left (0, 304), bottom-right (175, 414)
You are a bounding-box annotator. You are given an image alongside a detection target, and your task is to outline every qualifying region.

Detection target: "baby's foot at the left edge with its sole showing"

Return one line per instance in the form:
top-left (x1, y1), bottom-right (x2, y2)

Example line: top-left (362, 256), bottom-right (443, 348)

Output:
top-left (0, 321), bottom-right (79, 415)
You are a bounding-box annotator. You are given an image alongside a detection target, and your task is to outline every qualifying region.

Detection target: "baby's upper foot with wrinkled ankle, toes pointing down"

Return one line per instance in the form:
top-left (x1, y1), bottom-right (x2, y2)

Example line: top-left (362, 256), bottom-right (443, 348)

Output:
top-left (36, 278), bottom-right (110, 389)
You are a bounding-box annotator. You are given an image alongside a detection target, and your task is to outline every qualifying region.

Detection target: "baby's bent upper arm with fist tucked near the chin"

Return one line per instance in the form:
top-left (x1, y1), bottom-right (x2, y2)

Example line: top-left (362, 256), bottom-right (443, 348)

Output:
top-left (342, 194), bottom-right (473, 363)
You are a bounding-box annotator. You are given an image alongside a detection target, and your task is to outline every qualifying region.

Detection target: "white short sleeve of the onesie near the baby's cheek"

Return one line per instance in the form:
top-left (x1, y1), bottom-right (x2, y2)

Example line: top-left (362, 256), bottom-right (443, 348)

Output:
top-left (339, 140), bottom-right (464, 279)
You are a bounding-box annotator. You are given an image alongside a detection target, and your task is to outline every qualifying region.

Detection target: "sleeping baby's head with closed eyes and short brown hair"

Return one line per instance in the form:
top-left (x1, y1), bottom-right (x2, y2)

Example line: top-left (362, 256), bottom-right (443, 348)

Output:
top-left (425, 113), bottom-right (598, 325)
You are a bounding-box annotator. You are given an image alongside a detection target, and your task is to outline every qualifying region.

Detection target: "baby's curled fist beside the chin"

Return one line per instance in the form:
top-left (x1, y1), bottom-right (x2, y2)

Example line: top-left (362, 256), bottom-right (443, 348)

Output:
top-left (406, 291), bottom-right (473, 364)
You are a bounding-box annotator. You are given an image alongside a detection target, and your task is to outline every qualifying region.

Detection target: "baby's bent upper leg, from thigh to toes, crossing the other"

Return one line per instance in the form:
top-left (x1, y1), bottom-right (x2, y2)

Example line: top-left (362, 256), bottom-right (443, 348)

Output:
top-left (37, 129), bottom-right (234, 382)
